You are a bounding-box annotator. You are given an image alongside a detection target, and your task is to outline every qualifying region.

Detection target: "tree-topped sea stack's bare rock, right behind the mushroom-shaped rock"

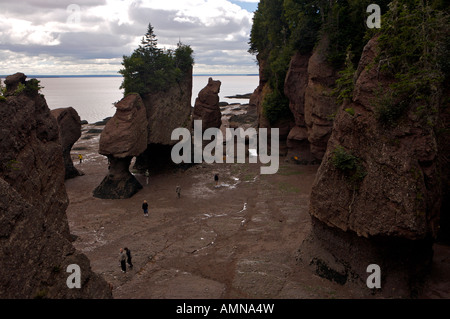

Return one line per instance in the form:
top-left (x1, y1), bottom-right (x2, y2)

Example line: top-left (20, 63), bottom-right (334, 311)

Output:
top-left (135, 68), bottom-right (192, 172)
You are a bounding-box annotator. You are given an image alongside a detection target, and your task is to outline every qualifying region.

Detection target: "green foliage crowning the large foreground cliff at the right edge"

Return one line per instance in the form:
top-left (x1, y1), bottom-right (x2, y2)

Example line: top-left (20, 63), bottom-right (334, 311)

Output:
top-left (376, 0), bottom-right (450, 126)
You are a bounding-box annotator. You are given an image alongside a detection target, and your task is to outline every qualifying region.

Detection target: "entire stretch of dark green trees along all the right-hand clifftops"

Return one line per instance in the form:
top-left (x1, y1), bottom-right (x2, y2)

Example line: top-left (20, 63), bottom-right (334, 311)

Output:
top-left (249, 0), bottom-right (450, 122)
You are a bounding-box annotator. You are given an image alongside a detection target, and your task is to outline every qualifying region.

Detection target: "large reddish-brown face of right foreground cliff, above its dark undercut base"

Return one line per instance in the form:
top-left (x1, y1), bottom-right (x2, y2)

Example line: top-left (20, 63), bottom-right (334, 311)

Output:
top-left (311, 40), bottom-right (440, 240)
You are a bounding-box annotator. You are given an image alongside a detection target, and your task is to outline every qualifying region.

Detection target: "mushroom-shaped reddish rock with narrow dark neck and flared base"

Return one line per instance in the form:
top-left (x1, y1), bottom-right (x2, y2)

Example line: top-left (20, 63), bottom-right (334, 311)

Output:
top-left (94, 94), bottom-right (148, 199)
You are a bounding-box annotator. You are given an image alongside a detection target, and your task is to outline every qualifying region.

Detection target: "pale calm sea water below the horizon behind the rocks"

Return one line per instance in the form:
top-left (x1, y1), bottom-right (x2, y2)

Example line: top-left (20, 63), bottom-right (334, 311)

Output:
top-left (29, 75), bottom-right (259, 123)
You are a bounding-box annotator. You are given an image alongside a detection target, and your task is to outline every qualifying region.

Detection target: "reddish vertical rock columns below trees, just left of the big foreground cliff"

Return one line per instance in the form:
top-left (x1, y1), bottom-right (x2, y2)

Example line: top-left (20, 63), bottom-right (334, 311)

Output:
top-left (284, 37), bottom-right (337, 162)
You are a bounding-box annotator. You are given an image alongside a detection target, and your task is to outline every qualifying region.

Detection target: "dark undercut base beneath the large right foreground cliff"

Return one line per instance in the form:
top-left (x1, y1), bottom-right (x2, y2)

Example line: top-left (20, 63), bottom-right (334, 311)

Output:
top-left (297, 217), bottom-right (433, 298)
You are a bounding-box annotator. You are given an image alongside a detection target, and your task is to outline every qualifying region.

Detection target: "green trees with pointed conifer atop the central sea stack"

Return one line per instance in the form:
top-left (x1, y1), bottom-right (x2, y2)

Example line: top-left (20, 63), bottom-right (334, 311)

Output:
top-left (119, 24), bottom-right (194, 95)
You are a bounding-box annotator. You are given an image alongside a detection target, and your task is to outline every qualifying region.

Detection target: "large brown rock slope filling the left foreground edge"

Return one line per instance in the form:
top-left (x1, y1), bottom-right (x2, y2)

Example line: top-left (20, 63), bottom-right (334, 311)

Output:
top-left (0, 74), bottom-right (112, 299)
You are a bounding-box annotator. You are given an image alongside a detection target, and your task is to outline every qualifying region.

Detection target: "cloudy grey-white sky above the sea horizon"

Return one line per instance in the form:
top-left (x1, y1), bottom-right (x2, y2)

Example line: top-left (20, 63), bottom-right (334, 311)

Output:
top-left (0, 0), bottom-right (259, 75)
